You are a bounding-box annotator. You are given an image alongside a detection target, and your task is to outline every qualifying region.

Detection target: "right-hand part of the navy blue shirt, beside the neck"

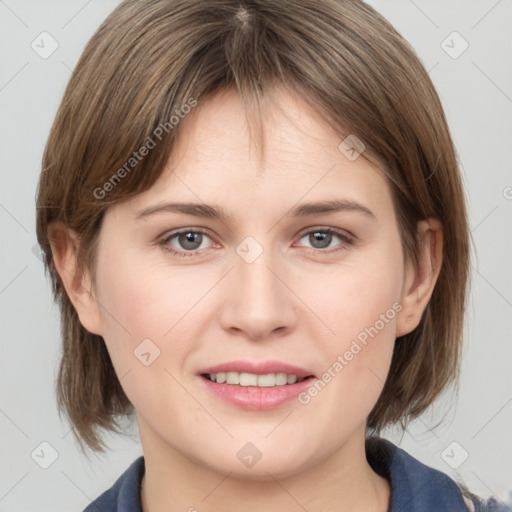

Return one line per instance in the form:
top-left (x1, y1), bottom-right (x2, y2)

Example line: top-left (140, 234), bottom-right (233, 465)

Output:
top-left (366, 437), bottom-right (512, 512)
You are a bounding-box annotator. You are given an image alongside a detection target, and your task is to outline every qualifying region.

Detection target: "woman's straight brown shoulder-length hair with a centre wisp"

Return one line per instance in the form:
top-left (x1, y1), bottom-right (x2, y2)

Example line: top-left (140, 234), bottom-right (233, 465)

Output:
top-left (37, 0), bottom-right (469, 451)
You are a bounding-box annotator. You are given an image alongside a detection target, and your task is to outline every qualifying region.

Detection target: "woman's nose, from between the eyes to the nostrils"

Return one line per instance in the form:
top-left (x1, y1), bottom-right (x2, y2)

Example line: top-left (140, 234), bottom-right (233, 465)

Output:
top-left (222, 237), bottom-right (295, 339)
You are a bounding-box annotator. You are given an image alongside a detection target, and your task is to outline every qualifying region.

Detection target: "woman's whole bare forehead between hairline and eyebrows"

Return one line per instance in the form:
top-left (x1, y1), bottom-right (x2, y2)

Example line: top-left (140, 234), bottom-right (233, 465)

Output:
top-left (118, 89), bottom-right (391, 224)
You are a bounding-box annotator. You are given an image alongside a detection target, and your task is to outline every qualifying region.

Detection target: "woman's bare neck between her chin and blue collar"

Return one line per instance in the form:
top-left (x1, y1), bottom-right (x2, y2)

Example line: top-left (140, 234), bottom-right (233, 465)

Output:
top-left (139, 420), bottom-right (391, 512)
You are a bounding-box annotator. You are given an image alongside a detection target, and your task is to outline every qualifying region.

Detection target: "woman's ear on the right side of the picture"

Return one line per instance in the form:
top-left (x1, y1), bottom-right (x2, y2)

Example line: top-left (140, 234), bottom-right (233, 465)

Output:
top-left (396, 219), bottom-right (443, 337)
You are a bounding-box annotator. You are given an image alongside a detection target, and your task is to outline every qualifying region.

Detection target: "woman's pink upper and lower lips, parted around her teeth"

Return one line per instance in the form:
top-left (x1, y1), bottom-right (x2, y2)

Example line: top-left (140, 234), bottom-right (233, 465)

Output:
top-left (199, 361), bottom-right (316, 411)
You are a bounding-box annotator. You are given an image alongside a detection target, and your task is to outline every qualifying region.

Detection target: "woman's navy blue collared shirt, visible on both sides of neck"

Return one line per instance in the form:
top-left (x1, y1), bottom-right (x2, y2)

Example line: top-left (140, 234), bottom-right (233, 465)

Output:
top-left (83, 438), bottom-right (512, 512)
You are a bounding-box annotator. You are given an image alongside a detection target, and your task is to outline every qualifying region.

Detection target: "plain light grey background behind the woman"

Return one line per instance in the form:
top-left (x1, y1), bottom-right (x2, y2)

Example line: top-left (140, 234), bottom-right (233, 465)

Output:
top-left (0, 0), bottom-right (512, 512)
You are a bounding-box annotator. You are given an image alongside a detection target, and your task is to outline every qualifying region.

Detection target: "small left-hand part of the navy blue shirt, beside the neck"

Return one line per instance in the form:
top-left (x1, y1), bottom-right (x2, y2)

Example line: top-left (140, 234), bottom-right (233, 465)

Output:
top-left (83, 455), bottom-right (145, 512)
